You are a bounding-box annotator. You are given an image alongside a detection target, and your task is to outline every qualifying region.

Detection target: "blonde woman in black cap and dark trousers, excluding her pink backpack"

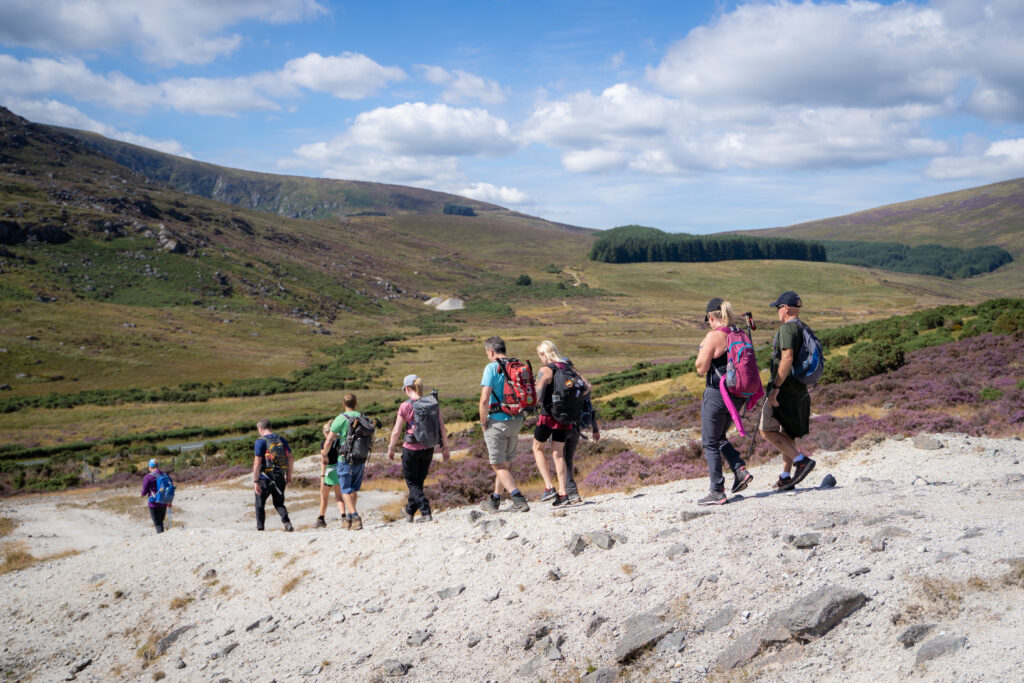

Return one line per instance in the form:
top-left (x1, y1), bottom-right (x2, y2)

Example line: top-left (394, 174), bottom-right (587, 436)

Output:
top-left (695, 297), bottom-right (754, 505)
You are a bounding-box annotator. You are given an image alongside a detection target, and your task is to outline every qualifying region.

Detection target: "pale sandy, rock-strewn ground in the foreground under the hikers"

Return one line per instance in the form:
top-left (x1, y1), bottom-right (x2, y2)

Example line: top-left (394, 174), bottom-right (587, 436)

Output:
top-left (0, 435), bottom-right (1024, 681)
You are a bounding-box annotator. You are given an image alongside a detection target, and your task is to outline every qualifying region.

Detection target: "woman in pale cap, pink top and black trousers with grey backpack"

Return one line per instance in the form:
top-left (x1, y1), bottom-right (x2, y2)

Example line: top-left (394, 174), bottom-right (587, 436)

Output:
top-left (387, 375), bottom-right (452, 522)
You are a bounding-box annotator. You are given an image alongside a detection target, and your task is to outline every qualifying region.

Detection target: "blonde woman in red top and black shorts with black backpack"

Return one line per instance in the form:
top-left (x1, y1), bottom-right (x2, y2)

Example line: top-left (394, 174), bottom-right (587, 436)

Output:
top-left (534, 341), bottom-right (590, 505)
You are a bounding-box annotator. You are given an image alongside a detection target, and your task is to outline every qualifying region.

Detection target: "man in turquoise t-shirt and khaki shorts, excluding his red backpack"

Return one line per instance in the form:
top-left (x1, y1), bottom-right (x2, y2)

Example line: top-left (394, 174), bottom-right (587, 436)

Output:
top-left (480, 337), bottom-right (529, 512)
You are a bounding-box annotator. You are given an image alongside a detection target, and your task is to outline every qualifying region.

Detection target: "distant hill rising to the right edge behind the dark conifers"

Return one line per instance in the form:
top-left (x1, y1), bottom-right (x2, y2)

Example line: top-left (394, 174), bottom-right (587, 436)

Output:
top-left (743, 178), bottom-right (1024, 258)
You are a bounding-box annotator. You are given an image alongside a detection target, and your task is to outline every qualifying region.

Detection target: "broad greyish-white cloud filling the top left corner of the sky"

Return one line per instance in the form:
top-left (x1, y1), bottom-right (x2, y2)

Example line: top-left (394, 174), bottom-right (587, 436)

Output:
top-left (0, 0), bottom-right (327, 66)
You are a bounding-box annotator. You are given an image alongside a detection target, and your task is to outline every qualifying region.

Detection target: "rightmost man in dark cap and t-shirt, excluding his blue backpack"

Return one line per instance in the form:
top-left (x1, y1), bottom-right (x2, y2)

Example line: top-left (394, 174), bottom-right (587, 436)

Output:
top-left (760, 292), bottom-right (814, 490)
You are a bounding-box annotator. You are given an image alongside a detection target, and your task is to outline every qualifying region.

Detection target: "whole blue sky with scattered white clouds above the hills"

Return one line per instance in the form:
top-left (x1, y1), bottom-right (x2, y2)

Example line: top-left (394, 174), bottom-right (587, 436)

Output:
top-left (0, 0), bottom-right (1024, 232)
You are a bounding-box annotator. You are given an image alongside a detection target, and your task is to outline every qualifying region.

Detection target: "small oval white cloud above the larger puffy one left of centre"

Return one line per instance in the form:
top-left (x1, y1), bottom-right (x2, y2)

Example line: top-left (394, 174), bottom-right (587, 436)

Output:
top-left (282, 52), bottom-right (406, 99)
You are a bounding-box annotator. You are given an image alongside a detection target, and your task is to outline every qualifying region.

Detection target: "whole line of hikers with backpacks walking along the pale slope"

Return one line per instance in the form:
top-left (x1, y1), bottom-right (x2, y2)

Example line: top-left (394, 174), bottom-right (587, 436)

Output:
top-left (148, 292), bottom-right (824, 532)
